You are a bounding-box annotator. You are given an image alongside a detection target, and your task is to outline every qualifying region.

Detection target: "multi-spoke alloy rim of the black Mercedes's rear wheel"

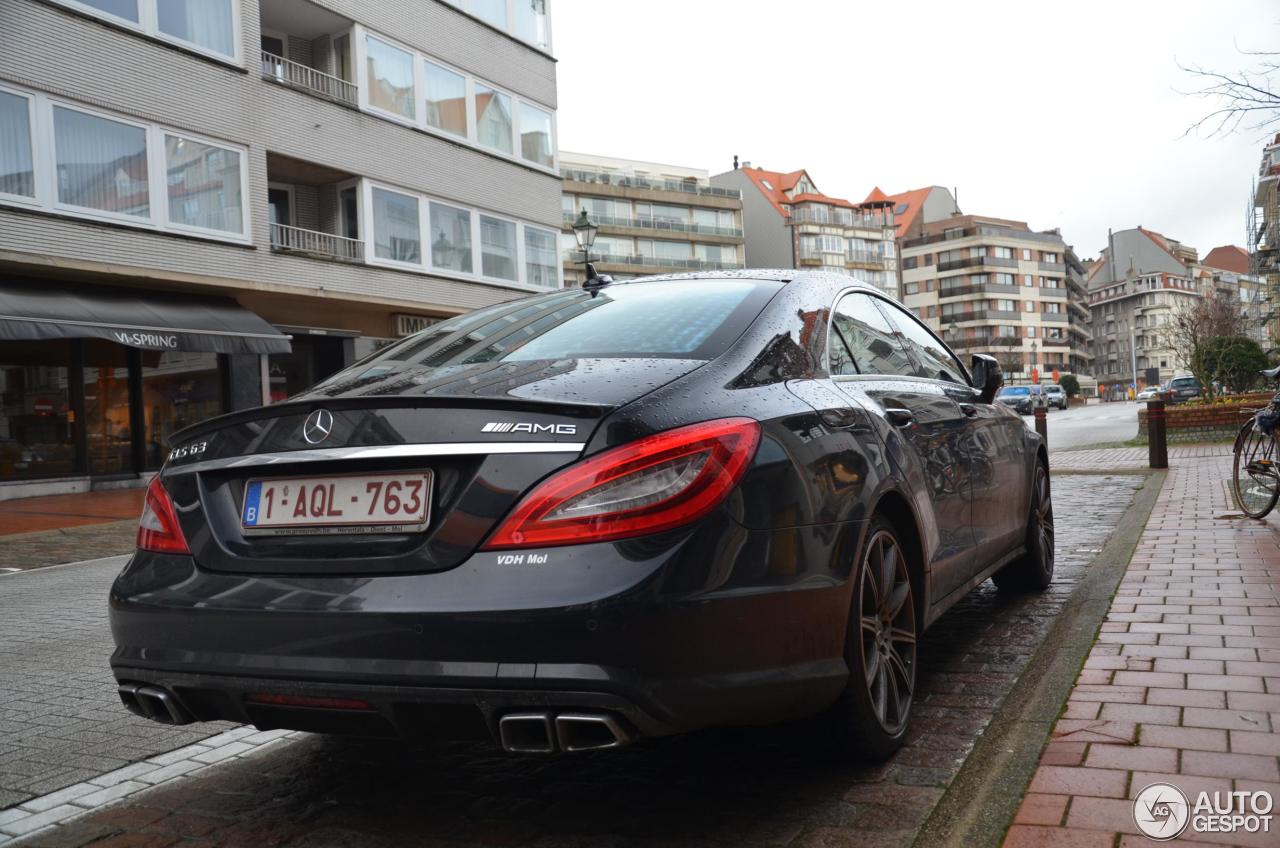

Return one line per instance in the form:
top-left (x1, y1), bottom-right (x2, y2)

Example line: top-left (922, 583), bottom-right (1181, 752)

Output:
top-left (859, 529), bottom-right (915, 735)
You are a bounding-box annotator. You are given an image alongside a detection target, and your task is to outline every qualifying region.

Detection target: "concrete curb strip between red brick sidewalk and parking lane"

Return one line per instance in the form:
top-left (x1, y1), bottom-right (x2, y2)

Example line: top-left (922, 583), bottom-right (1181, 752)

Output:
top-left (914, 470), bottom-right (1167, 848)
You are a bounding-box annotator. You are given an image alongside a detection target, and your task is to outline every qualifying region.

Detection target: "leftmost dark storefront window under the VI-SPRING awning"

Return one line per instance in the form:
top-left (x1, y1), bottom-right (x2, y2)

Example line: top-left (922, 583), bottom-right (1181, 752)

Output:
top-left (0, 342), bottom-right (76, 480)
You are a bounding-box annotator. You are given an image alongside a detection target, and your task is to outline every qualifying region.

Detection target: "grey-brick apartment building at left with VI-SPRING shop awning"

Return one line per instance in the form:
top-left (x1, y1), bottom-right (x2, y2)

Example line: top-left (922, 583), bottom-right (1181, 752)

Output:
top-left (0, 0), bottom-right (562, 498)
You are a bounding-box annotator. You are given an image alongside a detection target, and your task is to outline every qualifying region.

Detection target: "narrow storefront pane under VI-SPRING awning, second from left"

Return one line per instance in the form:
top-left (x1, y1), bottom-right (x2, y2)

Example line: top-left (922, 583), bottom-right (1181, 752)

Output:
top-left (83, 339), bottom-right (133, 474)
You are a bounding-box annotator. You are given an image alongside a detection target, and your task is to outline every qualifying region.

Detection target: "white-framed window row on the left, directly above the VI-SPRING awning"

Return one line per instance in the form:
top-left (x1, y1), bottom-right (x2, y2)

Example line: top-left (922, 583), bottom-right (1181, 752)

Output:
top-left (0, 86), bottom-right (253, 245)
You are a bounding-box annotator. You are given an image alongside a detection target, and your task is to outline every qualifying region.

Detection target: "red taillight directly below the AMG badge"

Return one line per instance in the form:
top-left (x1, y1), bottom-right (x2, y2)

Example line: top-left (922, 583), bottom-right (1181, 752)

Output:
top-left (484, 418), bottom-right (760, 551)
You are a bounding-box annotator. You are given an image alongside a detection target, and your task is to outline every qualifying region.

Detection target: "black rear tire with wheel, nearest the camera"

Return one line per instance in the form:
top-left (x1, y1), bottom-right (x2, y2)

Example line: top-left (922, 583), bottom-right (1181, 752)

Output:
top-left (822, 515), bottom-right (919, 760)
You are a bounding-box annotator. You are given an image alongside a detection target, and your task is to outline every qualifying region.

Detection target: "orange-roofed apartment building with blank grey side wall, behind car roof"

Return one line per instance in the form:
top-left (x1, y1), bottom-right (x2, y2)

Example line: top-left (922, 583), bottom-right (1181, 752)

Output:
top-left (710, 159), bottom-right (897, 297)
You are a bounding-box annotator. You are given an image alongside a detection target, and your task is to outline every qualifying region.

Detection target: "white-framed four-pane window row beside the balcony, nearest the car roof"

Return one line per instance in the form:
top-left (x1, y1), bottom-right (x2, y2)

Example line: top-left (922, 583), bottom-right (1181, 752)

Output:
top-left (357, 178), bottom-right (564, 292)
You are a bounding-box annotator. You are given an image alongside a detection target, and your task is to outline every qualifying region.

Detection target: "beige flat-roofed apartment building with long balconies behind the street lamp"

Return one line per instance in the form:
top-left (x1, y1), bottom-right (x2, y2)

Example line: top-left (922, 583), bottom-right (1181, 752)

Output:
top-left (561, 151), bottom-right (745, 286)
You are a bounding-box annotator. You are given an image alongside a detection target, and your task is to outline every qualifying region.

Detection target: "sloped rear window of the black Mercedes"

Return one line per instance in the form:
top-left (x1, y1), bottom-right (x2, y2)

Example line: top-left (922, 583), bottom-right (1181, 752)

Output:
top-left (352, 279), bottom-right (781, 377)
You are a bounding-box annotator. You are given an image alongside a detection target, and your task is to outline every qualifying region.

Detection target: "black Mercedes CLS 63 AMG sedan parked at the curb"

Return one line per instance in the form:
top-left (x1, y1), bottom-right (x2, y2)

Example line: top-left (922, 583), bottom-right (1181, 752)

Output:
top-left (110, 272), bottom-right (1053, 758)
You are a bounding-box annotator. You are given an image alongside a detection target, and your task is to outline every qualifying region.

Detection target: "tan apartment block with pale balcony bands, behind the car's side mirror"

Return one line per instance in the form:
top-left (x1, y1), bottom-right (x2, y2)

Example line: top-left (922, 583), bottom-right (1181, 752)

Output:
top-left (895, 216), bottom-right (1091, 380)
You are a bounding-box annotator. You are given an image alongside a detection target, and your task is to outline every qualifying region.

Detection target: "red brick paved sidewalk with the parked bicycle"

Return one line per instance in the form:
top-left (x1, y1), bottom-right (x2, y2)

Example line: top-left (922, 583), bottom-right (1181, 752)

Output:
top-left (1005, 451), bottom-right (1280, 847)
